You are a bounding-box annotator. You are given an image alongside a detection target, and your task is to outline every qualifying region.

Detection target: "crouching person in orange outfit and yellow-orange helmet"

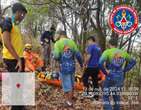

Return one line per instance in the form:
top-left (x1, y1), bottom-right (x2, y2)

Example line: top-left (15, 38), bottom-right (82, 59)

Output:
top-left (23, 44), bottom-right (44, 72)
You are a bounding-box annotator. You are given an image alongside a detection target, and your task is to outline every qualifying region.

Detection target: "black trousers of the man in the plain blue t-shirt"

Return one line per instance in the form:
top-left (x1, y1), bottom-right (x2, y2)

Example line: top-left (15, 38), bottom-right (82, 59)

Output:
top-left (83, 67), bottom-right (99, 92)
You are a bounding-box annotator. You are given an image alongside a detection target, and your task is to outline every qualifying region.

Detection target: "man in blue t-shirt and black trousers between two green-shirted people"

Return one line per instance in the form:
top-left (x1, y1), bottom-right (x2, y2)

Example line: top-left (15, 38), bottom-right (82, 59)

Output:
top-left (83, 36), bottom-right (101, 100)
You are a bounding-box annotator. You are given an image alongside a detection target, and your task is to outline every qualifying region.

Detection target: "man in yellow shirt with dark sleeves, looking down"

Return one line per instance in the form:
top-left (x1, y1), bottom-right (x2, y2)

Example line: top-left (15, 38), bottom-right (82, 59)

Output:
top-left (1, 3), bottom-right (27, 110)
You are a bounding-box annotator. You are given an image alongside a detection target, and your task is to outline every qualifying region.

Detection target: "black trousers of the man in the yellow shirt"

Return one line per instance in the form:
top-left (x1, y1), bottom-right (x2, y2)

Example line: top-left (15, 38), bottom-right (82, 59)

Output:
top-left (3, 58), bottom-right (25, 110)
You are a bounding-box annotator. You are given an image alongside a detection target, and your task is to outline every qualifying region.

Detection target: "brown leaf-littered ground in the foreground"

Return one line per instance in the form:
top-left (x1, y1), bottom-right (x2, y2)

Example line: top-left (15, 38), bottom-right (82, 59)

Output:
top-left (0, 81), bottom-right (141, 110)
